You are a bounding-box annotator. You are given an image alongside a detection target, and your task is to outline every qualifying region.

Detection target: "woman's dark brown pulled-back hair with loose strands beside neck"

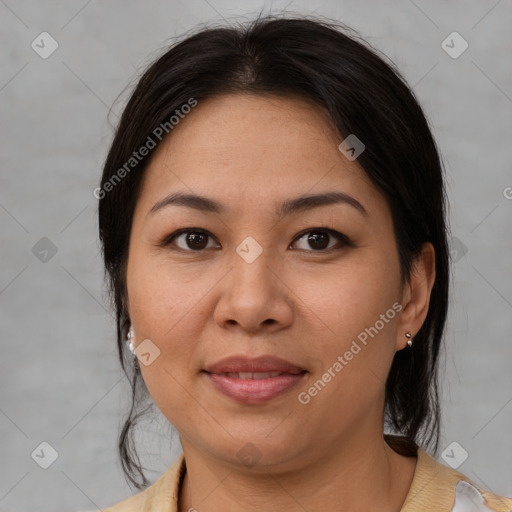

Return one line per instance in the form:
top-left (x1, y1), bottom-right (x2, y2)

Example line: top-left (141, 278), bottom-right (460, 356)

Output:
top-left (98, 16), bottom-right (449, 489)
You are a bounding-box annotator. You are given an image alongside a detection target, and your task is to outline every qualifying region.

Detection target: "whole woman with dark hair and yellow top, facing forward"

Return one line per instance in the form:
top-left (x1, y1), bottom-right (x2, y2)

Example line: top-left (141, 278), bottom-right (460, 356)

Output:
top-left (96, 17), bottom-right (512, 512)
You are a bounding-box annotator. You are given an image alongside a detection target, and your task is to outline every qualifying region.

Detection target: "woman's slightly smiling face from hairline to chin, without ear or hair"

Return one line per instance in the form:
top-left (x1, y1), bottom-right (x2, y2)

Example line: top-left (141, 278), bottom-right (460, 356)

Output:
top-left (127, 94), bottom-right (419, 469)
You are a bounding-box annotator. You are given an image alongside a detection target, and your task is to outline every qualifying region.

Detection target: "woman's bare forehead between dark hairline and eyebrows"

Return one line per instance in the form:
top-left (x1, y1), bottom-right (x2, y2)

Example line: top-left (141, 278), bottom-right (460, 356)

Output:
top-left (138, 94), bottom-right (383, 216)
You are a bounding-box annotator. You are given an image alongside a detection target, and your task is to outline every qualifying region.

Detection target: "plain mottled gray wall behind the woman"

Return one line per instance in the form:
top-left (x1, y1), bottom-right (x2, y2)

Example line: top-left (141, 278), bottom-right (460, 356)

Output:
top-left (0, 0), bottom-right (512, 512)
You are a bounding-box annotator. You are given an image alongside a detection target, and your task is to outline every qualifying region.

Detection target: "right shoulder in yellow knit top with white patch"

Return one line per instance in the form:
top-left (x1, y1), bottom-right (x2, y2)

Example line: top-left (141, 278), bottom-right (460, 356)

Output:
top-left (402, 449), bottom-right (512, 512)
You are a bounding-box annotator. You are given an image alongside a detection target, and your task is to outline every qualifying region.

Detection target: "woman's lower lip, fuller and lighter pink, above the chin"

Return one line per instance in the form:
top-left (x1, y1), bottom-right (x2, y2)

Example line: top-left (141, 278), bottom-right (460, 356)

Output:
top-left (205, 372), bottom-right (306, 404)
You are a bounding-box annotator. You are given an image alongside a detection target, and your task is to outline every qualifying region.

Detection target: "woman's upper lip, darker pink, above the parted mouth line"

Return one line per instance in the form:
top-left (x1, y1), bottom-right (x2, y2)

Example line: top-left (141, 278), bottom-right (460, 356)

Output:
top-left (205, 355), bottom-right (305, 374)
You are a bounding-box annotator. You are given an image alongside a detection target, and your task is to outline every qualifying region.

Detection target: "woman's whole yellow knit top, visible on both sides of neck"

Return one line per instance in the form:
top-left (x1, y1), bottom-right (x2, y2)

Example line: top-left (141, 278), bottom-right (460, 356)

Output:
top-left (104, 449), bottom-right (512, 512)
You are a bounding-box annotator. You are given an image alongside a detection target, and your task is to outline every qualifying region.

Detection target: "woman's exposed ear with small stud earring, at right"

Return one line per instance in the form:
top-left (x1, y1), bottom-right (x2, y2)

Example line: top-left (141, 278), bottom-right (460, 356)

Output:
top-left (396, 242), bottom-right (436, 350)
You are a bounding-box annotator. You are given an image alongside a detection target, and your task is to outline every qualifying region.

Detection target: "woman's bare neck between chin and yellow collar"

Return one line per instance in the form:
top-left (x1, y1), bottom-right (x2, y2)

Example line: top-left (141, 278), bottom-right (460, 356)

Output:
top-left (178, 432), bottom-right (416, 512)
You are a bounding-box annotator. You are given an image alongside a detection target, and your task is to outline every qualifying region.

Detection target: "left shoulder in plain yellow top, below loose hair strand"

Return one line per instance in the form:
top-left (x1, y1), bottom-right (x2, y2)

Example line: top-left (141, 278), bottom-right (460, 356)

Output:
top-left (103, 454), bottom-right (186, 512)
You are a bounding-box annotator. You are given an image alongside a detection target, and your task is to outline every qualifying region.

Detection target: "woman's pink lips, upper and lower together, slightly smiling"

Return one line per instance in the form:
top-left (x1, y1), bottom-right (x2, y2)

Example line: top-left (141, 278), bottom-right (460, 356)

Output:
top-left (204, 356), bottom-right (306, 404)
